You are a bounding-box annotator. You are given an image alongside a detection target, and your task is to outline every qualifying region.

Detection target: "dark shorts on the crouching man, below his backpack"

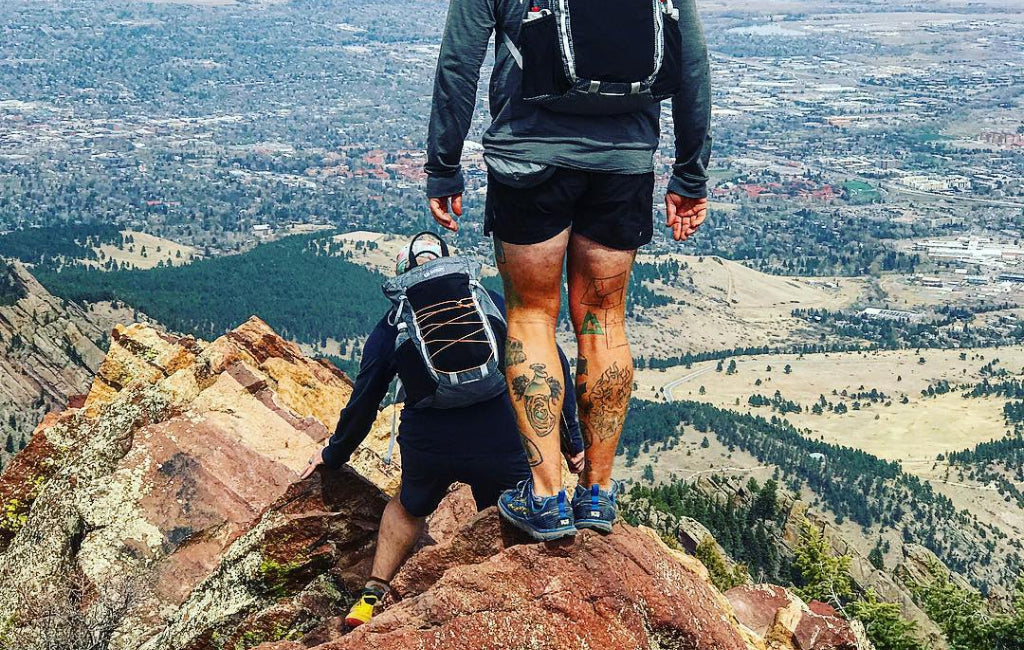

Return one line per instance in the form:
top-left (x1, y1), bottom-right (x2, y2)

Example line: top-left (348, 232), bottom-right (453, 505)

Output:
top-left (399, 445), bottom-right (529, 517)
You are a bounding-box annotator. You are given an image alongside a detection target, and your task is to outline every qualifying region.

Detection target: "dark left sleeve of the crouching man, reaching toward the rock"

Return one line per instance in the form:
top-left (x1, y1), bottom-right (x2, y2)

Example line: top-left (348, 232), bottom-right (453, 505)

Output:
top-left (324, 321), bottom-right (396, 469)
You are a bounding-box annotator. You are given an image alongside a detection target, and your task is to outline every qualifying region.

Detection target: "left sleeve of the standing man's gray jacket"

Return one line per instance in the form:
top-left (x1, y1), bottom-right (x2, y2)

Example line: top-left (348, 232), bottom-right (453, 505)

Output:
top-left (424, 0), bottom-right (495, 199)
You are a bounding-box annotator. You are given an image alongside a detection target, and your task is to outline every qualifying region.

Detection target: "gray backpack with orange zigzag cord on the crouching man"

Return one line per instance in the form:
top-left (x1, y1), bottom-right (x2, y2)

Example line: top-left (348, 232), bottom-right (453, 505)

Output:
top-left (383, 232), bottom-right (508, 408)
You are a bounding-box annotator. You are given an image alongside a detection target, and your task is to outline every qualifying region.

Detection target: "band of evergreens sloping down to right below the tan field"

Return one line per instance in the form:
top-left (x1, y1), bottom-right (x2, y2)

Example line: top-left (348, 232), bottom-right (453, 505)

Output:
top-left (620, 400), bottom-right (1022, 590)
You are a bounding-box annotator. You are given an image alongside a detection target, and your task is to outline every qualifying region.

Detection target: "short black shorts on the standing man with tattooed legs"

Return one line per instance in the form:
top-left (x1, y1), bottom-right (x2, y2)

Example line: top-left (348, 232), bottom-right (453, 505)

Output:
top-left (484, 167), bottom-right (654, 251)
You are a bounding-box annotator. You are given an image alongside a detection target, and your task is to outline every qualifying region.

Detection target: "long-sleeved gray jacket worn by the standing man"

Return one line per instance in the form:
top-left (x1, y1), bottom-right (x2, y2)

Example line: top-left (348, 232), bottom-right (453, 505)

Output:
top-left (424, 0), bottom-right (711, 198)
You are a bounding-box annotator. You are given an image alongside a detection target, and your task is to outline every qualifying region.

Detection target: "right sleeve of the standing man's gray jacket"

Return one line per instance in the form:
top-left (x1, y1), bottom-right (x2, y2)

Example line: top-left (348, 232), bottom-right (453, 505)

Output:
top-left (669, 0), bottom-right (712, 199)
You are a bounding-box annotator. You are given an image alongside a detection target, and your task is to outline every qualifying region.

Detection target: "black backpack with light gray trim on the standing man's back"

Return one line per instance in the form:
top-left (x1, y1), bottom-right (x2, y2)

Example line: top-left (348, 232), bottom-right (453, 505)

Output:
top-left (502, 0), bottom-right (682, 115)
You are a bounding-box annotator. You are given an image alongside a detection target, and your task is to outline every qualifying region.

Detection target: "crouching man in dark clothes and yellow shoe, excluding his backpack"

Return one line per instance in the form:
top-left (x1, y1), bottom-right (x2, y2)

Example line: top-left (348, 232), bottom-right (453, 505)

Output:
top-left (302, 237), bottom-right (583, 626)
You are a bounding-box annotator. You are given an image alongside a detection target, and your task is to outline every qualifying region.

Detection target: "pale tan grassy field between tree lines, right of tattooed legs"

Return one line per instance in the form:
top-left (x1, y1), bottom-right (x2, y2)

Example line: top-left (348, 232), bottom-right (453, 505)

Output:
top-left (637, 347), bottom-right (1024, 460)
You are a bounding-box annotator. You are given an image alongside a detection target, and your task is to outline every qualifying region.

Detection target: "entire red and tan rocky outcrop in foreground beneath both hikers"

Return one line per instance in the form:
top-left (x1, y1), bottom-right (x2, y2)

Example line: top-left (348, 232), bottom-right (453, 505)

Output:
top-left (0, 318), bottom-right (864, 650)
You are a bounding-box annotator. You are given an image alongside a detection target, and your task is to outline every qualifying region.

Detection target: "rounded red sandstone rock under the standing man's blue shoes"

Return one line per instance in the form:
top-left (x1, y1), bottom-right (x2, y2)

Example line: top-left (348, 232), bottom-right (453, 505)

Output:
top-left (331, 517), bottom-right (750, 650)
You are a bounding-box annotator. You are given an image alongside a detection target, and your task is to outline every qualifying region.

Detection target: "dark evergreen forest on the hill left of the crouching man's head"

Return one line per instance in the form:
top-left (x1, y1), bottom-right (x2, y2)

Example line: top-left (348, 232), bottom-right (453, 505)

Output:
top-left (37, 235), bottom-right (389, 343)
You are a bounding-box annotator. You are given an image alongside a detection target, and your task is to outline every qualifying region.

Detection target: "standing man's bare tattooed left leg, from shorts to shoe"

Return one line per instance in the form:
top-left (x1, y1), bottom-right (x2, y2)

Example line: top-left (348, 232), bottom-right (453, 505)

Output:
top-left (495, 229), bottom-right (569, 496)
